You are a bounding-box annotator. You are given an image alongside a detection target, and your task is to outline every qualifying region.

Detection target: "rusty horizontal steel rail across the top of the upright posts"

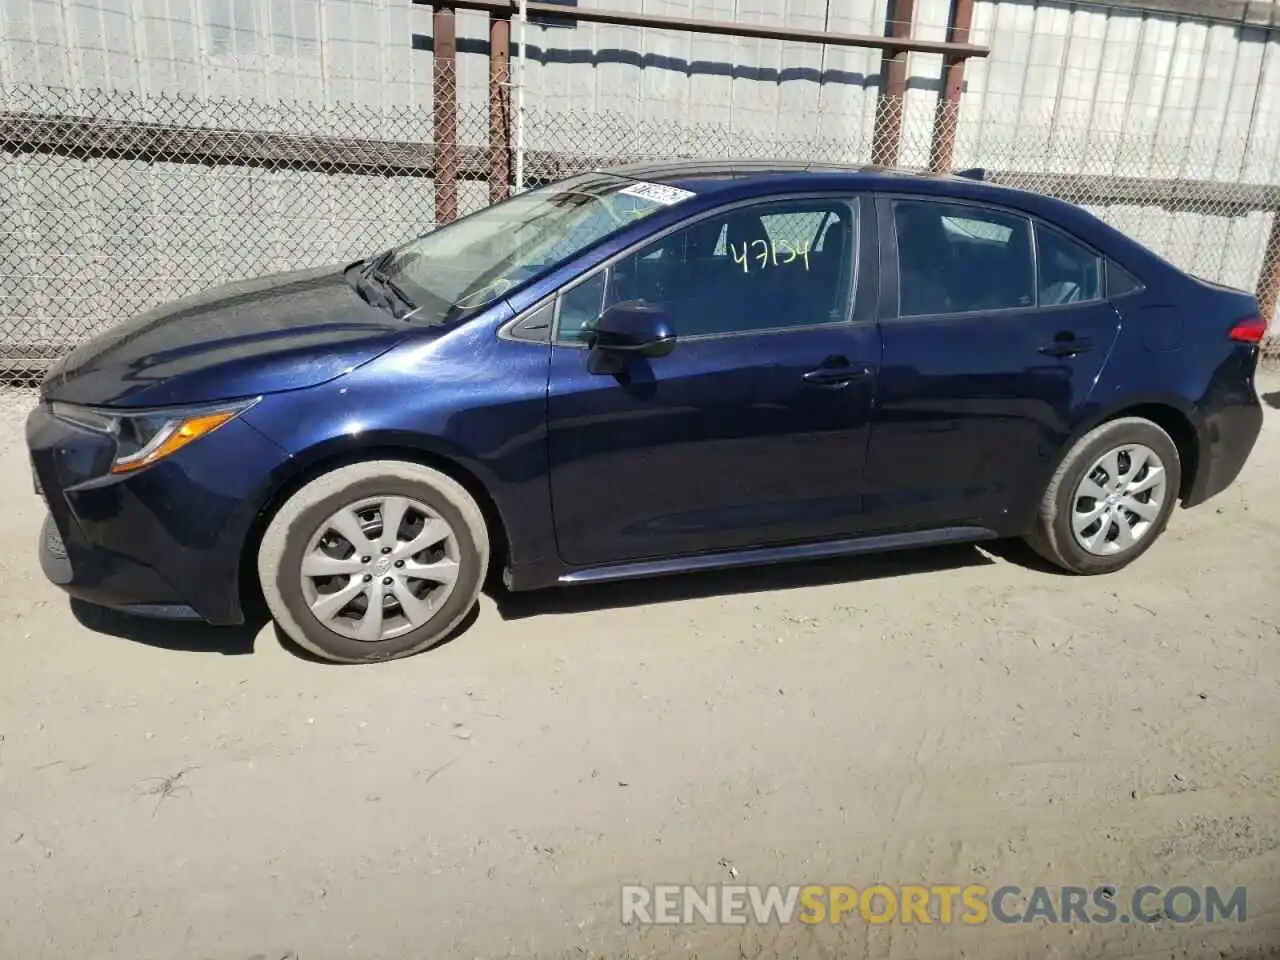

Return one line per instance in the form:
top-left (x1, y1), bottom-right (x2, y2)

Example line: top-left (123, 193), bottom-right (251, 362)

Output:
top-left (413, 0), bottom-right (991, 58)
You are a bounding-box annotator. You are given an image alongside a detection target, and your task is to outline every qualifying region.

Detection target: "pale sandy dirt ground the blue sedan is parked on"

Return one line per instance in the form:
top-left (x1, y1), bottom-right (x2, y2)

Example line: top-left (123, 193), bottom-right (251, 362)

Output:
top-left (0, 376), bottom-right (1280, 960)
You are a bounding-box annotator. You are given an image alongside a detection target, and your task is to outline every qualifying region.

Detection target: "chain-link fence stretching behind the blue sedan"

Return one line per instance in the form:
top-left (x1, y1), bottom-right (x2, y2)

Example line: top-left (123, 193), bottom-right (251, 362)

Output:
top-left (0, 77), bottom-right (1280, 385)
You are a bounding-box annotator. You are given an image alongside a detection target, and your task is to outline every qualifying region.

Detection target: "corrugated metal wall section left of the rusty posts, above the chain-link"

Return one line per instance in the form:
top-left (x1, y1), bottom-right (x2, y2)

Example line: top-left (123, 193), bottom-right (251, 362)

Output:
top-left (0, 0), bottom-right (431, 115)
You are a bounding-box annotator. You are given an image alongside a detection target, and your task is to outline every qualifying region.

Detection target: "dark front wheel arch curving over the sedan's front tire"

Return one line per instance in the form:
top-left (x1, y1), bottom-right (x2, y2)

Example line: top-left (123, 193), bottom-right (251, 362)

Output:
top-left (232, 435), bottom-right (511, 616)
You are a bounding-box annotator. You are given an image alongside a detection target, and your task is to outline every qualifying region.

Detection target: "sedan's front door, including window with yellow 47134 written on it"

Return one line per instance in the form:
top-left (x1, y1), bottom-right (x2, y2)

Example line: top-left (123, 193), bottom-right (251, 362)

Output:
top-left (548, 198), bottom-right (879, 566)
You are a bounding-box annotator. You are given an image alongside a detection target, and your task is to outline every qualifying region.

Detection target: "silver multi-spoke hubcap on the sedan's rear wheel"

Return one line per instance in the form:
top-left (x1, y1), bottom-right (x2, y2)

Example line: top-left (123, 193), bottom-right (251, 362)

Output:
top-left (1071, 443), bottom-right (1165, 557)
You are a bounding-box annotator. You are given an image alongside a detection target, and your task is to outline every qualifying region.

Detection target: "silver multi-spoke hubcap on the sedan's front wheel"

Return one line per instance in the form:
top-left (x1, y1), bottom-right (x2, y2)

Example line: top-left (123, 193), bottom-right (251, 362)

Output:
top-left (300, 497), bottom-right (460, 643)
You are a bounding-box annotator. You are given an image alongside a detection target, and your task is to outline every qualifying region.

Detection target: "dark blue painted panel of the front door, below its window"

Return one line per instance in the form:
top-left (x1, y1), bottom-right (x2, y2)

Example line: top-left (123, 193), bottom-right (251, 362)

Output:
top-left (547, 324), bottom-right (879, 566)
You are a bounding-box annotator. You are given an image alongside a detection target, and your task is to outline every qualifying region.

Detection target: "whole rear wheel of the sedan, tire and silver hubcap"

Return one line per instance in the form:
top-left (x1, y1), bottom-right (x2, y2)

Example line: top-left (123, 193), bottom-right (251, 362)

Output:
top-left (1028, 417), bottom-right (1181, 573)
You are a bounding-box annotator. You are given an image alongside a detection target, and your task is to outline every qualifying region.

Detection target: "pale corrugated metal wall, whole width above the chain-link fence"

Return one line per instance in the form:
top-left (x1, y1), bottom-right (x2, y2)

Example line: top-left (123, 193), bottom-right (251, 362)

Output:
top-left (0, 0), bottom-right (1280, 154)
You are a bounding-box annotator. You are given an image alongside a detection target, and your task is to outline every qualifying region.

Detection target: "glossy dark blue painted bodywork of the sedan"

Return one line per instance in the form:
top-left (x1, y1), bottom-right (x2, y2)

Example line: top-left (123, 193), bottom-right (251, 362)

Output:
top-left (27, 164), bottom-right (1261, 623)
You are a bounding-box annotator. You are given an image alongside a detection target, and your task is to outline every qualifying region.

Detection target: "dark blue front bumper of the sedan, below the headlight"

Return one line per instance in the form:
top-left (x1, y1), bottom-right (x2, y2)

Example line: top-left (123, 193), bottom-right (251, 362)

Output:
top-left (27, 403), bottom-right (287, 625)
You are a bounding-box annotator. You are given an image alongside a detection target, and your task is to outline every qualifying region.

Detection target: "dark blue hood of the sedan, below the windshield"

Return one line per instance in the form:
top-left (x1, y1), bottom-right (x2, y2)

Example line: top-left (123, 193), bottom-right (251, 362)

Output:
top-left (41, 266), bottom-right (408, 407)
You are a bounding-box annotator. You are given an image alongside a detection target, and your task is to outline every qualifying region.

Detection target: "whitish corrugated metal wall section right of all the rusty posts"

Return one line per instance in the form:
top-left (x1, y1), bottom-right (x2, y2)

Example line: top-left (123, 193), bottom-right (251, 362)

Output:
top-left (964, 3), bottom-right (1280, 180)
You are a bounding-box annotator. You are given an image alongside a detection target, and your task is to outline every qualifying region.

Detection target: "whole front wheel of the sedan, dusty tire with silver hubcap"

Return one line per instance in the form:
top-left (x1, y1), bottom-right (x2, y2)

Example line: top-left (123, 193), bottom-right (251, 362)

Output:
top-left (257, 461), bottom-right (489, 663)
